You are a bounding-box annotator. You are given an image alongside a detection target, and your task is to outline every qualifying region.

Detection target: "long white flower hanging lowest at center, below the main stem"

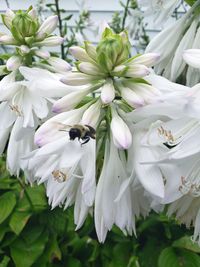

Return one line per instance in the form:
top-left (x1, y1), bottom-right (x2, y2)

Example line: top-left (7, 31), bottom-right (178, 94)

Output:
top-left (95, 140), bottom-right (150, 242)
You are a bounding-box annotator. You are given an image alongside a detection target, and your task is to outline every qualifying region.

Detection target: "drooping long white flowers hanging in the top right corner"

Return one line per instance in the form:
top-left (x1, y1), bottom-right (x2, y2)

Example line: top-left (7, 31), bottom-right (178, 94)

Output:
top-left (146, 1), bottom-right (200, 86)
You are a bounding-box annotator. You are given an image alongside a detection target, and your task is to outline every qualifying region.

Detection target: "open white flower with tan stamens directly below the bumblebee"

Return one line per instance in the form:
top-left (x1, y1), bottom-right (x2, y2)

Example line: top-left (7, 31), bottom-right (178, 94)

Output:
top-left (23, 132), bottom-right (96, 228)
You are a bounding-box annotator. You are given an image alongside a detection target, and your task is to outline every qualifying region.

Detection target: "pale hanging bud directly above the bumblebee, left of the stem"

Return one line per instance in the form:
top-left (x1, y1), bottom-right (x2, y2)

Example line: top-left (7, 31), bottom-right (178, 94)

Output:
top-left (81, 100), bottom-right (101, 128)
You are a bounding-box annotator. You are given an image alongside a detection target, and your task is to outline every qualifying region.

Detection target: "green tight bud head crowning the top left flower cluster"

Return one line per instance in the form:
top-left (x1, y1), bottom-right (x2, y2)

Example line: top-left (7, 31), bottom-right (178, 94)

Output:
top-left (11, 11), bottom-right (38, 42)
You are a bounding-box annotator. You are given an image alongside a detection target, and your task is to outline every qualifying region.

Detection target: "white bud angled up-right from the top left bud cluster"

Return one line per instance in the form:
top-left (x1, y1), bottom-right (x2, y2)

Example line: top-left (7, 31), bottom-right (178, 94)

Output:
top-left (36, 16), bottom-right (58, 40)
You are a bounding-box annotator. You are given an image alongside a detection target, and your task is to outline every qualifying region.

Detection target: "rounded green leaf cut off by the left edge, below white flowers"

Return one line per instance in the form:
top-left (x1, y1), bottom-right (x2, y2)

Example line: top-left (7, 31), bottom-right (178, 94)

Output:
top-left (0, 192), bottom-right (16, 223)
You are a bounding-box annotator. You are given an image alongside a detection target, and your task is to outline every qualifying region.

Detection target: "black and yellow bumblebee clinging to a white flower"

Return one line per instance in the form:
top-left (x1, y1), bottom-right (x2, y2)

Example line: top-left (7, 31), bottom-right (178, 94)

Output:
top-left (69, 124), bottom-right (96, 145)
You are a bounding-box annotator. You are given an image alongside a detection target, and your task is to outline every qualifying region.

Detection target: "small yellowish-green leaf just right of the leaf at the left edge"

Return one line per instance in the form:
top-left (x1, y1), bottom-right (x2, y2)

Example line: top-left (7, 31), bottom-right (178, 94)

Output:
top-left (9, 211), bottom-right (31, 235)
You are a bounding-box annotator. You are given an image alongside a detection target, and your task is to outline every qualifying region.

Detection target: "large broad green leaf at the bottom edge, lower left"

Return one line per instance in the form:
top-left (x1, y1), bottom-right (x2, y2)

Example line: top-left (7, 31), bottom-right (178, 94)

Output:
top-left (10, 228), bottom-right (48, 267)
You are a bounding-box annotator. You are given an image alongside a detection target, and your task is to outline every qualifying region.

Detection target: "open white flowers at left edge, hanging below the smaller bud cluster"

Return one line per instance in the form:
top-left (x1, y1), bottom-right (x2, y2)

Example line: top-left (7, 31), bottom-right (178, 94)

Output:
top-left (0, 67), bottom-right (72, 174)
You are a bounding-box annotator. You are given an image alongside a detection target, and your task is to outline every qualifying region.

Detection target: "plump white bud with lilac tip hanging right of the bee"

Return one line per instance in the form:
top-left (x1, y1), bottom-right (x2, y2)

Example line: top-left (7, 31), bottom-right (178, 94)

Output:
top-left (110, 108), bottom-right (132, 149)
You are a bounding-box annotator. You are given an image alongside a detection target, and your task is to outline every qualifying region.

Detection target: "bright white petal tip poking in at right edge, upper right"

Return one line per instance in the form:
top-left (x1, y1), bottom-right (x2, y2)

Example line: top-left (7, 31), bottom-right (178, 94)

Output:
top-left (183, 49), bottom-right (200, 69)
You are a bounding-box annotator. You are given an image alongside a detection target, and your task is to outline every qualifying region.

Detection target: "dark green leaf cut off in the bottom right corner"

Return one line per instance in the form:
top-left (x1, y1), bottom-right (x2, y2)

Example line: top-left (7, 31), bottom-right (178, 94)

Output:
top-left (158, 247), bottom-right (200, 267)
